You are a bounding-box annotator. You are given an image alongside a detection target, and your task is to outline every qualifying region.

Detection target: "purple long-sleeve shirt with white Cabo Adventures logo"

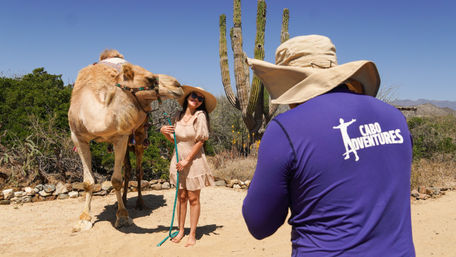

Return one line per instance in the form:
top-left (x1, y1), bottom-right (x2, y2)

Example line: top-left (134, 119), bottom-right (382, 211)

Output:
top-left (242, 88), bottom-right (415, 256)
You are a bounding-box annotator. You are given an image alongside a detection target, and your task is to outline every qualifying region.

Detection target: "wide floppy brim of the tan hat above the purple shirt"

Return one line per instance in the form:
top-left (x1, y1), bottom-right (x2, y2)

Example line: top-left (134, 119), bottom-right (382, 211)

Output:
top-left (247, 59), bottom-right (380, 104)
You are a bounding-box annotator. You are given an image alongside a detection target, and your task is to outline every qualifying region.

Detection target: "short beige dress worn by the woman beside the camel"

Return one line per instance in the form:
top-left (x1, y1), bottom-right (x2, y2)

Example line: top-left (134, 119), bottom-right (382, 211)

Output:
top-left (169, 111), bottom-right (214, 191)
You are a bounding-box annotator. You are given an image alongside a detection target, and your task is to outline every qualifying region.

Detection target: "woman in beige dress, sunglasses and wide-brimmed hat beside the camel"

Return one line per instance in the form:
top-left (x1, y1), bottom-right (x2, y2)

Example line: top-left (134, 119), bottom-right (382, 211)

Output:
top-left (160, 86), bottom-right (217, 246)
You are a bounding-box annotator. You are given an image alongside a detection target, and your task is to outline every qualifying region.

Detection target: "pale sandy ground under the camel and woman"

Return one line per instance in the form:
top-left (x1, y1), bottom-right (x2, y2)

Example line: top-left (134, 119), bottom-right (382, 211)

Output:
top-left (0, 187), bottom-right (456, 257)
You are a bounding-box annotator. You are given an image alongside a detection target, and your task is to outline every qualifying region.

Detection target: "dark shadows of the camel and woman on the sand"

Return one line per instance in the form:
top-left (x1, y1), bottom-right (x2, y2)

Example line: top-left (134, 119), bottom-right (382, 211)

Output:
top-left (93, 194), bottom-right (223, 237)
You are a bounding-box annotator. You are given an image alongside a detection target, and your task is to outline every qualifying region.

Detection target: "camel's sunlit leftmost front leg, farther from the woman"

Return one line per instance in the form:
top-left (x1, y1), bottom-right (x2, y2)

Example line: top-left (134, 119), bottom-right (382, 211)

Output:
top-left (71, 133), bottom-right (95, 232)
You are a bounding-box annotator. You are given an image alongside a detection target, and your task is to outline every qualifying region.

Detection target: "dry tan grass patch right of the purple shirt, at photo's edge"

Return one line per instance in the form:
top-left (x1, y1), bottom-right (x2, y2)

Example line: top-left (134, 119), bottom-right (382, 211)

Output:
top-left (411, 155), bottom-right (456, 189)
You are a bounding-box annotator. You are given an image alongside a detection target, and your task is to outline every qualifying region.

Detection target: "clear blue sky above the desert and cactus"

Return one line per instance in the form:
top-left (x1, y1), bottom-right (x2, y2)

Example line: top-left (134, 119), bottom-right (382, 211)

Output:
top-left (0, 0), bottom-right (456, 101)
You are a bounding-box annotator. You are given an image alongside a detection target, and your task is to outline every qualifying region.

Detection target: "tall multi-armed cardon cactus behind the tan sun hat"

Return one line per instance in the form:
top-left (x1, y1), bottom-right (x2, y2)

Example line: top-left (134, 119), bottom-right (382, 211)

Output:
top-left (219, 0), bottom-right (289, 139)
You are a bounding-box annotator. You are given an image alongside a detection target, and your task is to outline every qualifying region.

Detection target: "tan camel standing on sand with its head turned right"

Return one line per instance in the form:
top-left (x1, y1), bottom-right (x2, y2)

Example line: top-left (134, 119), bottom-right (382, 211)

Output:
top-left (68, 50), bottom-right (183, 232)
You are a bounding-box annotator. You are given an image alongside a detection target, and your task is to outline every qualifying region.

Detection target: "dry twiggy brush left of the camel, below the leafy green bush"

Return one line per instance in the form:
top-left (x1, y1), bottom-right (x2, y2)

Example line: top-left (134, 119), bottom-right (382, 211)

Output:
top-left (0, 115), bottom-right (82, 185)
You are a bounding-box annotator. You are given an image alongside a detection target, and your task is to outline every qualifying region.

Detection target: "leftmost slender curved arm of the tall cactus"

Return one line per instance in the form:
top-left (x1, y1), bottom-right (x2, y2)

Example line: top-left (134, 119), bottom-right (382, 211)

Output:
top-left (219, 14), bottom-right (241, 110)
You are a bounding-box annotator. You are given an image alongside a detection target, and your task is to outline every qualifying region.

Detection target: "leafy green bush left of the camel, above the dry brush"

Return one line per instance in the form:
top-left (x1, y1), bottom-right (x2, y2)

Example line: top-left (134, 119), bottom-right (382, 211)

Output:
top-left (0, 68), bottom-right (72, 145)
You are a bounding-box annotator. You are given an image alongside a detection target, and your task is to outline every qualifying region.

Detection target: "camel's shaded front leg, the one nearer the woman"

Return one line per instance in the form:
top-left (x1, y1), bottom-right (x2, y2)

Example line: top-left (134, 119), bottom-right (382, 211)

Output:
top-left (111, 136), bottom-right (133, 228)
